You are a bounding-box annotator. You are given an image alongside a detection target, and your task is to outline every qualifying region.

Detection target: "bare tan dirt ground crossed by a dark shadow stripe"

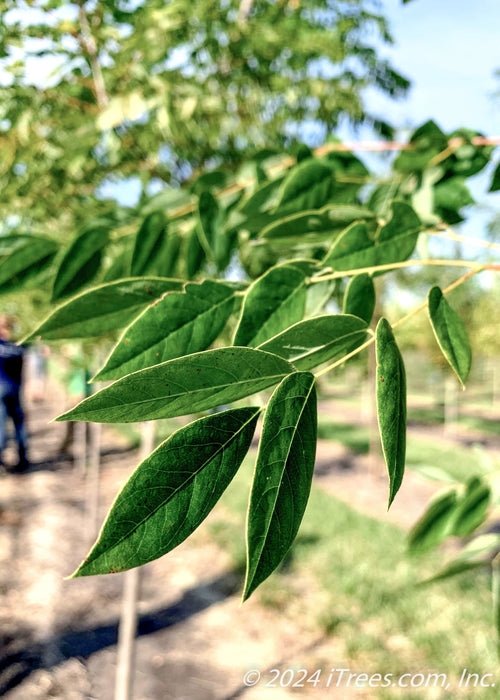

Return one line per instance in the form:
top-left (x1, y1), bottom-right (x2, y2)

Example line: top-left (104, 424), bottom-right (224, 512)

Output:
top-left (0, 387), bottom-right (500, 700)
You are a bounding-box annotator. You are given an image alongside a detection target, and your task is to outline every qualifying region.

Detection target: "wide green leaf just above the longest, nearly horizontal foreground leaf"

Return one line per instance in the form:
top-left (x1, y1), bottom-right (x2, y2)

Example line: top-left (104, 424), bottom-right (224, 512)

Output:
top-left (94, 280), bottom-right (234, 381)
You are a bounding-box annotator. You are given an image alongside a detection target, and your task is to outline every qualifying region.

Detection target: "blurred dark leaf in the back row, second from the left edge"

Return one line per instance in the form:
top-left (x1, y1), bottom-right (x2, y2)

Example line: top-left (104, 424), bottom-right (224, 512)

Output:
top-left (52, 226), bottom-right (109, 301)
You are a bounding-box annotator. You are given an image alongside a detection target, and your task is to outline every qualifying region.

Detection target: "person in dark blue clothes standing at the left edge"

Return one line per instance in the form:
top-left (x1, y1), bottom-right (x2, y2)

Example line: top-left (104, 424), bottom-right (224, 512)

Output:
top-left (0, 314), bottom-right (29, 472)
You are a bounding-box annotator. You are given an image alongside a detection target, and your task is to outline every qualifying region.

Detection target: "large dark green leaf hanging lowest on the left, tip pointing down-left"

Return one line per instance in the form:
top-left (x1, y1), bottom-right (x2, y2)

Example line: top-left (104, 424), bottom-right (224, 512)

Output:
top-left (73, 408), bottom-right (260, 577)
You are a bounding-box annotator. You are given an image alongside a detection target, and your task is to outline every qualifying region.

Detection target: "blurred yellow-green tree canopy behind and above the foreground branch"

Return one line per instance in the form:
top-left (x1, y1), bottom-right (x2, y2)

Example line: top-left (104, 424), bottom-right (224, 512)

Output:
top-left (0, 0), bottom-right (409, 234)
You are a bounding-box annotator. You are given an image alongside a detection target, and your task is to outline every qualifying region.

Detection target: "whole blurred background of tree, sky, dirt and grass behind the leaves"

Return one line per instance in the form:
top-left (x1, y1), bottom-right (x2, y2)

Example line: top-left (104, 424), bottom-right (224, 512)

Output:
top-left (0, 0), bottom-right (500, 700)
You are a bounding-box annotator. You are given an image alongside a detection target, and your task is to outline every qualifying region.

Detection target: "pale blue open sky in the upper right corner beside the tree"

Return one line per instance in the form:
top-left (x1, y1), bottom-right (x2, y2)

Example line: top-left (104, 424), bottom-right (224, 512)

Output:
top-left (370, 0), bottom-right (500, 135)
